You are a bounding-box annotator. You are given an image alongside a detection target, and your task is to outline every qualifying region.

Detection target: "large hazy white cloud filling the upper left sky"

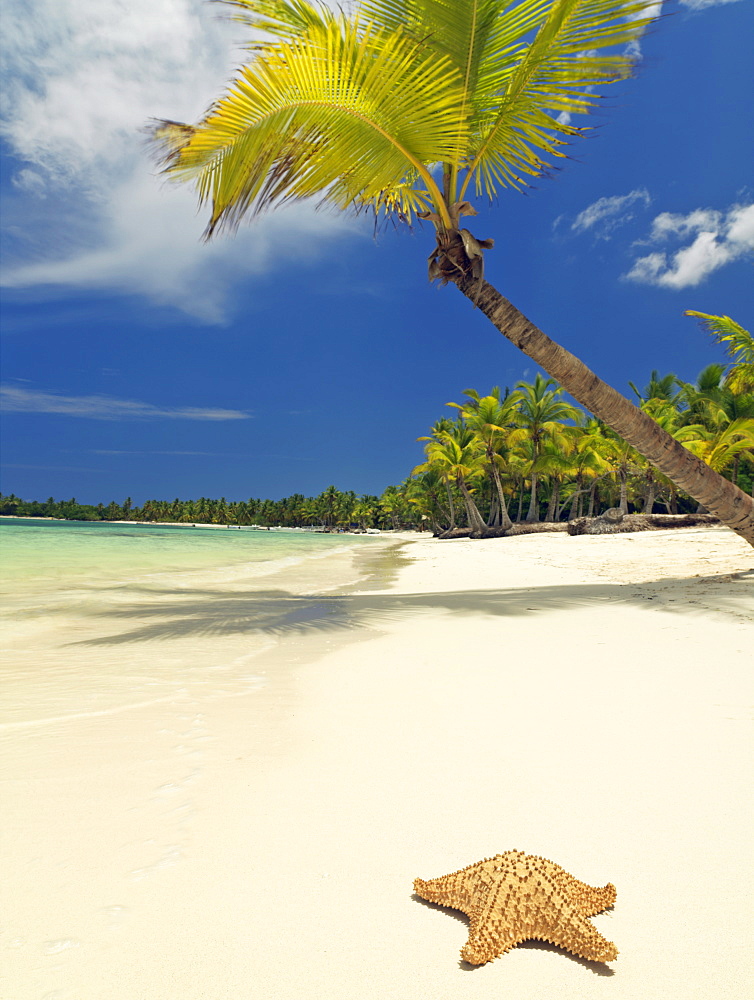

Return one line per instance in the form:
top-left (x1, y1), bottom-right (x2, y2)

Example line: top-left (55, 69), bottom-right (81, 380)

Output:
top-left (0, 0), bottom-right (361, 322)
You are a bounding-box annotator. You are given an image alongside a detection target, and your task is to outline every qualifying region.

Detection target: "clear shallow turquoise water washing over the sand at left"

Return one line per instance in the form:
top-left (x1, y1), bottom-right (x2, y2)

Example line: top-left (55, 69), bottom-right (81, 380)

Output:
top-left (0, 519), bottom-right (392, 729)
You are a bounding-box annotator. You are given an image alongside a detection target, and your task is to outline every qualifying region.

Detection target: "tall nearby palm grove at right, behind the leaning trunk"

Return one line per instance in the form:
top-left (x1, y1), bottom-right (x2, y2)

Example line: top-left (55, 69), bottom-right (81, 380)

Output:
top-left (407, 312), bottom-right (754, 534)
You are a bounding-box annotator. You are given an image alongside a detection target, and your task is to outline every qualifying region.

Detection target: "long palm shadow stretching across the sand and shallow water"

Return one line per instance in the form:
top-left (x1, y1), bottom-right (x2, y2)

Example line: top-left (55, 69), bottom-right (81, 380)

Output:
top-left (71, 573), bottom-right (754, 646)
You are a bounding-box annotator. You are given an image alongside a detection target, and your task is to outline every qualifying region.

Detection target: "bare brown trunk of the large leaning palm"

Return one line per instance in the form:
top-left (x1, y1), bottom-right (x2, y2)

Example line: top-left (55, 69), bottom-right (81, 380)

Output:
top-left (451, 272), bottom-right (754, 546)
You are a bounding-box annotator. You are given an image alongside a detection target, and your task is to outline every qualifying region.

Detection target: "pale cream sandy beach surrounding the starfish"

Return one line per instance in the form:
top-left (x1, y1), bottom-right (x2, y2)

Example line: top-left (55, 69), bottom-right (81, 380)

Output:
top-left (0, 528), bottom-right (754, 1000)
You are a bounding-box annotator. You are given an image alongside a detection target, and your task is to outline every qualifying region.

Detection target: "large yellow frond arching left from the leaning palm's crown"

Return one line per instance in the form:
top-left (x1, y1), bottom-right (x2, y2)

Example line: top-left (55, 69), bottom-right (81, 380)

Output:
top-left (147, 17), bottom-right (465, 233)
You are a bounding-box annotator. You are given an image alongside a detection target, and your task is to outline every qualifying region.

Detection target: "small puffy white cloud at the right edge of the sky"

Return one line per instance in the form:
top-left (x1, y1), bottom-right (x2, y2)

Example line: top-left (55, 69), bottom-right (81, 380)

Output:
top-left (625, 204), bottom-right (754, 289)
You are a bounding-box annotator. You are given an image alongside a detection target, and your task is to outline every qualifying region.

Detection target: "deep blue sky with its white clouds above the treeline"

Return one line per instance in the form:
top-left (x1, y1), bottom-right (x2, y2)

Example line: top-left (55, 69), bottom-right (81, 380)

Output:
top-left (0, 0), bottom-right (754, 503)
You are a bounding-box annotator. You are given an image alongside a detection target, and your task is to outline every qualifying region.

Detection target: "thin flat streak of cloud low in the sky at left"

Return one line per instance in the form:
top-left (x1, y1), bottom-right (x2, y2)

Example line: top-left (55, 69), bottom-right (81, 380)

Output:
top-left (0, 385), bottom-right (251, 420)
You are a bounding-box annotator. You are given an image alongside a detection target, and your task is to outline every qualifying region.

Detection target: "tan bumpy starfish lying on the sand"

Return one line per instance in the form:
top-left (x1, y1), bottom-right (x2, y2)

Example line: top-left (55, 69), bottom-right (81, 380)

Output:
top-left (414, 851), bottom-right (618, 965)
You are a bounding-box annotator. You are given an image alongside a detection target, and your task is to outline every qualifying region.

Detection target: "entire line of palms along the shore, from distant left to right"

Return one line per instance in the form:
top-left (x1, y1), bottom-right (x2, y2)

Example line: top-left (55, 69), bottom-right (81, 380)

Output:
top-left (0, 314), bottom-right (754, 534)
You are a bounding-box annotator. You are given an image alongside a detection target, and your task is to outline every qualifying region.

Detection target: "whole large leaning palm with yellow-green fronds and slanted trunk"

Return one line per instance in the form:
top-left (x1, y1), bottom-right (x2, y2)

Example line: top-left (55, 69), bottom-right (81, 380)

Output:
top-left (148, 0), bottom-right (754, 545)
